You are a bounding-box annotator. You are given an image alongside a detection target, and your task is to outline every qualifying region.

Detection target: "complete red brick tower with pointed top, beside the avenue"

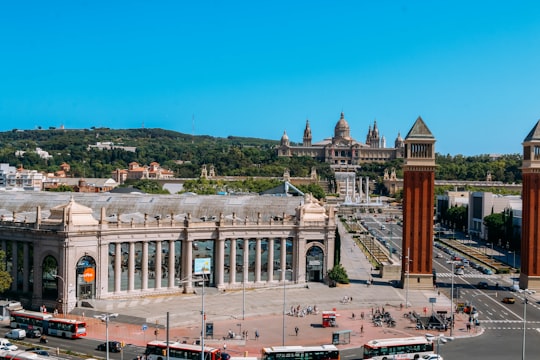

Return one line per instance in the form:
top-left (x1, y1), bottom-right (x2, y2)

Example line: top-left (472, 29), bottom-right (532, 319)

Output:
top-left (401, 117), bottom-right (436, 289)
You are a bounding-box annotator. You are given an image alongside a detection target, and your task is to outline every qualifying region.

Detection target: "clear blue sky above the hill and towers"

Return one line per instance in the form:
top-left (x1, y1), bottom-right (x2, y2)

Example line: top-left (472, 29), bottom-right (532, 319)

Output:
top-left (0, 0), bottom-right (540, 155)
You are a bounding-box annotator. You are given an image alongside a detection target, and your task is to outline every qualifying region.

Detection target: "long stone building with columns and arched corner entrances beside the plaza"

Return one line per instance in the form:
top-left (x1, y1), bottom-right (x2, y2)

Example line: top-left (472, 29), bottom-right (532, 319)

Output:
top-left (0, 193), bottom-right (336, 311)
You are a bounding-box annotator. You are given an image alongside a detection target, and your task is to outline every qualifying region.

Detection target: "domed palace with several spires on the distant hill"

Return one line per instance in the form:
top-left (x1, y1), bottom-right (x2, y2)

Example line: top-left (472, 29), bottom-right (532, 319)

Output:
top-left (277, 113), bottom-right (404, 167)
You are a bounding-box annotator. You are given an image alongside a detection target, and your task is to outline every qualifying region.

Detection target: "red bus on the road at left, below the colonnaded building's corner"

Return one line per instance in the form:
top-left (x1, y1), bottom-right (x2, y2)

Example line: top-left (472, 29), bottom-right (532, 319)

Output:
top-left (9, 310), bottom-right (86, 339)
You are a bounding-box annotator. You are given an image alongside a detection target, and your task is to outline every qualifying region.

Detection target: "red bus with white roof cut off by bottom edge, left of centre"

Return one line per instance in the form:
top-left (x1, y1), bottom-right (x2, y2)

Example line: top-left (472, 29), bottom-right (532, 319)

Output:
top-left (144, 340), bottom-right (221, 360)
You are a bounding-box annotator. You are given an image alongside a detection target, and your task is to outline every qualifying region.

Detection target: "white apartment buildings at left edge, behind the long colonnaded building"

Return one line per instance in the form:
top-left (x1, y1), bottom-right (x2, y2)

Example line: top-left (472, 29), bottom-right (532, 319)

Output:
top-left (0, 164), bottom-right (44, 191)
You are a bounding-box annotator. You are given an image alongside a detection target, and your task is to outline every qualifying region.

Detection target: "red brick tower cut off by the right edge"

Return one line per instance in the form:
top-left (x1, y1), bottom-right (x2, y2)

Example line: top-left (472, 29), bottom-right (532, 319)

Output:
top-left (519, 121), bottom-right (540, 290)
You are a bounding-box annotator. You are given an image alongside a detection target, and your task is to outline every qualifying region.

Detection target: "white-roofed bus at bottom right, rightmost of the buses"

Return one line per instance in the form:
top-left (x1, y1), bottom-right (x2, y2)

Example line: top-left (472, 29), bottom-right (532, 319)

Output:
top-left (363, 336), bottom-right (434, 360)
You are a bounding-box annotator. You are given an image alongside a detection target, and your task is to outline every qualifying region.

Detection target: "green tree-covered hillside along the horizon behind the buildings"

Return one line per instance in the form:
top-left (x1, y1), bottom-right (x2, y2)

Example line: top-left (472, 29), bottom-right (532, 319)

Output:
top-left (0, 128), bottom-right (522, 192)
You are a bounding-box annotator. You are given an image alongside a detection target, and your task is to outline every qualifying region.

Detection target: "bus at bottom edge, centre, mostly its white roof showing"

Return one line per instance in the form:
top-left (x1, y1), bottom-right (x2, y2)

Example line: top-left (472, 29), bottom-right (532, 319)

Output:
top-left (261, 345), bottom-right (339, 360)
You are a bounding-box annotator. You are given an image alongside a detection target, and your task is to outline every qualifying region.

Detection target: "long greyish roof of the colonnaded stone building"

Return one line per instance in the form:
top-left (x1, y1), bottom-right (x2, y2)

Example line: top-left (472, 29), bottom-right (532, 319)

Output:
top-left (0, 192), bottom-right (304, 222)
